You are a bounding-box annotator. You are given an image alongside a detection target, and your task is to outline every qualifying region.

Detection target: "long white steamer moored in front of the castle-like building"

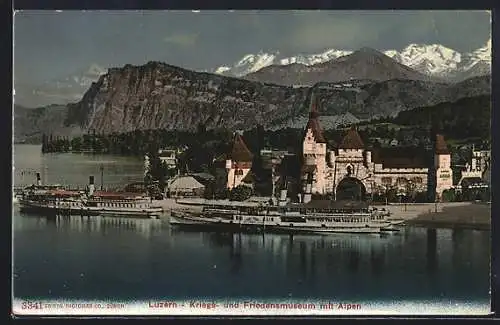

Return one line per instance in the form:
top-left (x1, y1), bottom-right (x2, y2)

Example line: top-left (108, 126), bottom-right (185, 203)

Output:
top-left (170, 201), bottom-right (390, 233)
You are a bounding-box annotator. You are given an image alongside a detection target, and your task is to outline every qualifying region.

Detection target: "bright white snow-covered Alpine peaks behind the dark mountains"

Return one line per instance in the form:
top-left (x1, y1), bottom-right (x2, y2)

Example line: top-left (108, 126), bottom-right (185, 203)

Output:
top-left (213, 39), bottom-right (491, 78)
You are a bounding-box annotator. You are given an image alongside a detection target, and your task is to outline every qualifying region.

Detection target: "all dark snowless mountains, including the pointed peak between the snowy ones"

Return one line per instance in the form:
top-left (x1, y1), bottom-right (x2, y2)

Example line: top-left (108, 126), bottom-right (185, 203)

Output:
top-left (14, 40), bottom-right (491, 141)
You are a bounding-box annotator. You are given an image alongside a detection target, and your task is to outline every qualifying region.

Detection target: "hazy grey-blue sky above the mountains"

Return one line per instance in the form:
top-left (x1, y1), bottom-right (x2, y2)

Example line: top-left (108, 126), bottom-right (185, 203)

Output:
top-left (14, 10), bottom-right (491, 106)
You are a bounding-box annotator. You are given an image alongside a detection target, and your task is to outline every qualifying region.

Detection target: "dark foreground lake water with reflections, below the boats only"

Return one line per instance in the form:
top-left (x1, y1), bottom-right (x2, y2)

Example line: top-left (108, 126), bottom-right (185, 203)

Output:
top-left (15, 216), bottom-right (488, 299)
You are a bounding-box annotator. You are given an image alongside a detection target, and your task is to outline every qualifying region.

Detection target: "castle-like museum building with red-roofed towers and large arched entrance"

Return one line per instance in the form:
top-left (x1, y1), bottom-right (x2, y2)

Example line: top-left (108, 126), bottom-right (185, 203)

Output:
top-left (301, 96), bottom-right (453, 202)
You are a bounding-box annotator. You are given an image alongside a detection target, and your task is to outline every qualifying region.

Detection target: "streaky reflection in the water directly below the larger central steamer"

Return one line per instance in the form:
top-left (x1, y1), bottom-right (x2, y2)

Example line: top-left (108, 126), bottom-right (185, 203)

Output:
top-left (199, 233), bottom-right (393, 279)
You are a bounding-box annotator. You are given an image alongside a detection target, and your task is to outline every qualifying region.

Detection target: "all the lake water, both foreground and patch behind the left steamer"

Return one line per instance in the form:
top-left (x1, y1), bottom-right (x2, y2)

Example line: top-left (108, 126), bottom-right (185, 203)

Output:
top-left (13, 145), bottom-right (490, 314)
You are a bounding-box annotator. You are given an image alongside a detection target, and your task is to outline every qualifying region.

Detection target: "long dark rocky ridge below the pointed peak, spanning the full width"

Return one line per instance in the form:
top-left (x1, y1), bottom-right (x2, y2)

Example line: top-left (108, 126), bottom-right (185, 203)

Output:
top-left (15, 62), bottom-right (490, 140)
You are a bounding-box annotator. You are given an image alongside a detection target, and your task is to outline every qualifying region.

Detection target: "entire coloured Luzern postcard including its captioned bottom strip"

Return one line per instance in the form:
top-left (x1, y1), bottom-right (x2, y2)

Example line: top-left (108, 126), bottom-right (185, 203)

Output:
top-left (12, 10), bottom-right (491, 317)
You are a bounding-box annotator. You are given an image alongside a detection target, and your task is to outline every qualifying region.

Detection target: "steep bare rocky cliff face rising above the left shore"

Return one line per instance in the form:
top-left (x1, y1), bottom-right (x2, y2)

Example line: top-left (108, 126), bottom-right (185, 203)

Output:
top-left (66, 62), bottom-right (308, 133)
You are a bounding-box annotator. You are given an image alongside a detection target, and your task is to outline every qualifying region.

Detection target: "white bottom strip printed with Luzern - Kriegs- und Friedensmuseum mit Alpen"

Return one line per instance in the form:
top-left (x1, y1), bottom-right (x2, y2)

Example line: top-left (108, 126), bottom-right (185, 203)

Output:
top-left (12, 298), bottom-right (491, 316)
